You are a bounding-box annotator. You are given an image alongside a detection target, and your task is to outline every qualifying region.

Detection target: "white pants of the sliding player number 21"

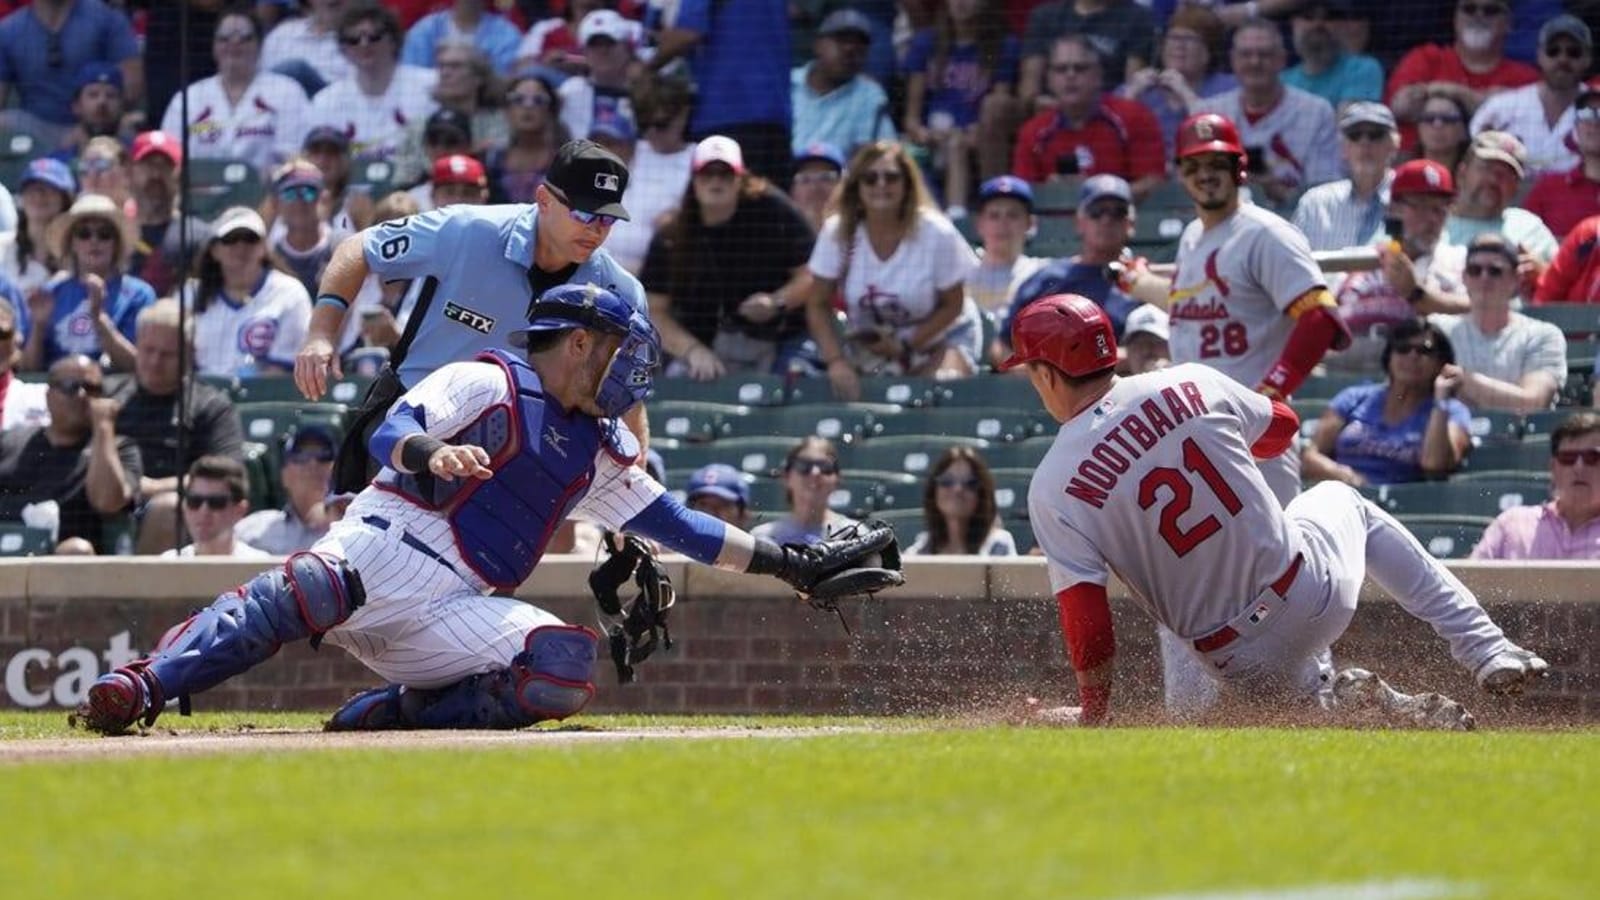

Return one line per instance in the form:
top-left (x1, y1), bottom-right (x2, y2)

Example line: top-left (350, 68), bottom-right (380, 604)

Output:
top-left (1192, 482), bottom-right (1510, 695)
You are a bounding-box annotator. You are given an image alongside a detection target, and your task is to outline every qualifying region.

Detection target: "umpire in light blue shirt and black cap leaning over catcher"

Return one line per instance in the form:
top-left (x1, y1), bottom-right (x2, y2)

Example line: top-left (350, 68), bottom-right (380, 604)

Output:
top-left (294, 141), bottom-right (648, 492)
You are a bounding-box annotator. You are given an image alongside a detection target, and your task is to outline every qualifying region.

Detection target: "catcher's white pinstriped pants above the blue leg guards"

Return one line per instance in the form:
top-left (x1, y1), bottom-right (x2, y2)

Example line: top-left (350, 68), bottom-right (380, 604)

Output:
top-left (312, 519), bottom-right (562, 687)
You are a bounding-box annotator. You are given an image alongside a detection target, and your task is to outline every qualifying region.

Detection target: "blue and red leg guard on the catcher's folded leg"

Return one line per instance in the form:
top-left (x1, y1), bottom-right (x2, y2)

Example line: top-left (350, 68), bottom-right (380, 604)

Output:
top-left (326, 625), bottom-right (598, 732)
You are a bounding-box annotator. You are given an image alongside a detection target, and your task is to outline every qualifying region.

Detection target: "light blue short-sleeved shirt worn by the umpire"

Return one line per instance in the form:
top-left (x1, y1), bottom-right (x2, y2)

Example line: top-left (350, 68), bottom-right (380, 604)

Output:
top-left (362, 203), bottom-right (648, 388)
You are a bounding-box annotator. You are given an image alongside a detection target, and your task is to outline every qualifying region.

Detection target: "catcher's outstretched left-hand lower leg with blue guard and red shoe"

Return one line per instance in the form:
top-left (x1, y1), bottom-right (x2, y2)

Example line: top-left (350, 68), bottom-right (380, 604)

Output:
top-left (78, 551), bottom-right (366, 733)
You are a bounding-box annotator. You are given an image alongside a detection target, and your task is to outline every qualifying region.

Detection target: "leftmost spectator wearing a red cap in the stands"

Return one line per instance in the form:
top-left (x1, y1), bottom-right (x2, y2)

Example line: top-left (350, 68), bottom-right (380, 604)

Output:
top-left (130, 131), bottom-right (211, 296)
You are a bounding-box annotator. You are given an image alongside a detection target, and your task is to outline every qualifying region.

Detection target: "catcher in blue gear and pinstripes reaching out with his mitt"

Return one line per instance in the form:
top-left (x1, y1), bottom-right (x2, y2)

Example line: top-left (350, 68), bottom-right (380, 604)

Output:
top-left (78, 285), bottom-right (902, 733)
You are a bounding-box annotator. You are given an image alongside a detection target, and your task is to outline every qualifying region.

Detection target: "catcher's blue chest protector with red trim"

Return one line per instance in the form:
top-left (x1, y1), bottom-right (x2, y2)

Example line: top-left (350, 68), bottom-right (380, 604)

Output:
top-left (381, 349), bottom-right (638, 591)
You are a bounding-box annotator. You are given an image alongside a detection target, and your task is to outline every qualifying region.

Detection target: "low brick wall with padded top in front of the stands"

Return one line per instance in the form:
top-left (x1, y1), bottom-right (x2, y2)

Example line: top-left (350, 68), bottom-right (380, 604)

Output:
top-left (0, 560), bottom-right (1600, 722)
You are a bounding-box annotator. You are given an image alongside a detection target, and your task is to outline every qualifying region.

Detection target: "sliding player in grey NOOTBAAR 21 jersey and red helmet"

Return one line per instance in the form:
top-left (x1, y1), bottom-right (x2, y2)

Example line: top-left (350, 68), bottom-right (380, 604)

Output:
top-left (1002, 295), bottom-right (1549, 729)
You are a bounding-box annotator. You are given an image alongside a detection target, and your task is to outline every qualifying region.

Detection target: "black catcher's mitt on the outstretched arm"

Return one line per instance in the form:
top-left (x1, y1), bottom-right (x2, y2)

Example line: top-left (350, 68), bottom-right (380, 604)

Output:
top-left (750, 520), bottom-right (906, 610)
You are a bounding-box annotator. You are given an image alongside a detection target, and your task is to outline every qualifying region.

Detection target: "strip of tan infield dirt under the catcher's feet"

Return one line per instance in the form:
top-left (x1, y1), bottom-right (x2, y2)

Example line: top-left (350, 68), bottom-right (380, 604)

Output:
top-left (0, 725), bottom-right (883, 765)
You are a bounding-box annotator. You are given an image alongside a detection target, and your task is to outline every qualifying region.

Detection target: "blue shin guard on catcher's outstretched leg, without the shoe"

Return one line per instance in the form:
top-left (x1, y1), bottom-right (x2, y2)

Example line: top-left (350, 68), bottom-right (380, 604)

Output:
top-left (147, 552), bottom-right (365, 711)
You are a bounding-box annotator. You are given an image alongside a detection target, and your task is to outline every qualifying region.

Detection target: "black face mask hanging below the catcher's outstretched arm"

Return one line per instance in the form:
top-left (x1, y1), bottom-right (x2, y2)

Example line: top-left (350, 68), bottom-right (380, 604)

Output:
top-left (589, 533), bottom-right (677, 684)
